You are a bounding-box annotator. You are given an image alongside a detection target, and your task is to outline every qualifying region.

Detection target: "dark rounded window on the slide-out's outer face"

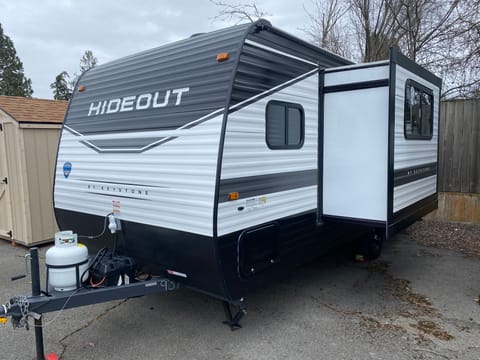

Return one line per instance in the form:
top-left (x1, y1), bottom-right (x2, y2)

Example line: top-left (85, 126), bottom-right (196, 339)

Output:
top-left (404, 79), bottom-right (433, 140)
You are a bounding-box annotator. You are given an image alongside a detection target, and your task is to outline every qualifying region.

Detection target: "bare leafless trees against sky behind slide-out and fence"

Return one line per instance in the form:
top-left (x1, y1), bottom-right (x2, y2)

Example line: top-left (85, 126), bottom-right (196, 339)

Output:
top-left (304, 0), bottom-right (480, 97)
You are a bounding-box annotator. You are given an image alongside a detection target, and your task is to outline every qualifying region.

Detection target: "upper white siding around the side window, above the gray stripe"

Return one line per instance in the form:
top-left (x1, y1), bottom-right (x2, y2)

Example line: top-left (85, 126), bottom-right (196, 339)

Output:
top-left (221, 74), bottom-right (318, 179)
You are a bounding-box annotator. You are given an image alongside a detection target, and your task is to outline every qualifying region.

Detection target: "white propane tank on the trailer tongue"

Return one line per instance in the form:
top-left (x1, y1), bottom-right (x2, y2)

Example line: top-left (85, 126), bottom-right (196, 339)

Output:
top-left (45, 231), bottom-right (88, 291)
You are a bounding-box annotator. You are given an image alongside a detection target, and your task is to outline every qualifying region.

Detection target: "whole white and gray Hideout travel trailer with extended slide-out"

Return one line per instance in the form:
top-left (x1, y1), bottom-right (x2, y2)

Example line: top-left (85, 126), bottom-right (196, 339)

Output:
top-left (54, 20), bottom-right (441, 304)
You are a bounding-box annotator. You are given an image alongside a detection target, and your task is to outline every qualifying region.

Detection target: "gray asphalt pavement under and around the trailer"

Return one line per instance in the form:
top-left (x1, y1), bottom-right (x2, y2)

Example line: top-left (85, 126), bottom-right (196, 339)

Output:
top-left (0, 234), bottom-right (480, 360)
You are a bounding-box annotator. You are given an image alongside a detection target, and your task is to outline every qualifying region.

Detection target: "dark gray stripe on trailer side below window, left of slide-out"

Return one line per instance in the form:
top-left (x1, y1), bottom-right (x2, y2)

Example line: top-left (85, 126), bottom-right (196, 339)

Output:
top-left (218, 169), bottom-right (318, 203)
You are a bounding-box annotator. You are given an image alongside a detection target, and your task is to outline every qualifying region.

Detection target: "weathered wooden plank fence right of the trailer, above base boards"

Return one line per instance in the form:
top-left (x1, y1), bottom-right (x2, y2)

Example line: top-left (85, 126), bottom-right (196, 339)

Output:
top-left (438, 99), bottom-right (480, 194)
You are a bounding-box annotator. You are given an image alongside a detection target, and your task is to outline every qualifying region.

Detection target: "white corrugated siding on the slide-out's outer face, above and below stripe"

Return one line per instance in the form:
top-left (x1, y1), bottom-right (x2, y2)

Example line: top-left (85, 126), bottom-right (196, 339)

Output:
top-left (393, 65), bottom-right (440, 212)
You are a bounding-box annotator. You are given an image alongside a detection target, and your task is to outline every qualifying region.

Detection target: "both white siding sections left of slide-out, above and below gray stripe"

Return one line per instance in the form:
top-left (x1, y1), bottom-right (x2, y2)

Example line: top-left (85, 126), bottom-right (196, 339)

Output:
top-left (218, 73), bottom-right (318, 235)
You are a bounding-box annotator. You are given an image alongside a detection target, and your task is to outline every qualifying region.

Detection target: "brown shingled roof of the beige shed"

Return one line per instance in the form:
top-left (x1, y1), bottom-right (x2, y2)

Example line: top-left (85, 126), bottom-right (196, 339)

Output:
top-left (0, 96), bottom-right (68, 124)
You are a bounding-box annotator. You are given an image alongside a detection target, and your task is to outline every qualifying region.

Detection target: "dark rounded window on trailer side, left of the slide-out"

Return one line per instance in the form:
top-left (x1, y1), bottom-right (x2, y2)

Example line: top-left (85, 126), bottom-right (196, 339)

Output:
top-left (266, 101), bottom-right (305, 149)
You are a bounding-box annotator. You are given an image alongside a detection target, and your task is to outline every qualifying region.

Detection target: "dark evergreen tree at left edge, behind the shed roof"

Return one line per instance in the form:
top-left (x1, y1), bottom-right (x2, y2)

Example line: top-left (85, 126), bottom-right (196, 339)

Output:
top-left (0, 24), bottom-right (33, 97)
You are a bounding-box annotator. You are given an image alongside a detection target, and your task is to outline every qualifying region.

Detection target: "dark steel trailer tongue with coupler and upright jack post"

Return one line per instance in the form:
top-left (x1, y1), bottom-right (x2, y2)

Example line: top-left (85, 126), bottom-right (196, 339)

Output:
top-left (0, 247), bottom-right (178, 360)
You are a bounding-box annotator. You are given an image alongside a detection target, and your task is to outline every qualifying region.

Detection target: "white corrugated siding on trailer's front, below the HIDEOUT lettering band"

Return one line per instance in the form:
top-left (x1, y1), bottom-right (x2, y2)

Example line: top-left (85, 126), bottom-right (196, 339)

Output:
top-left (55, 115), bottom-right (222, 236)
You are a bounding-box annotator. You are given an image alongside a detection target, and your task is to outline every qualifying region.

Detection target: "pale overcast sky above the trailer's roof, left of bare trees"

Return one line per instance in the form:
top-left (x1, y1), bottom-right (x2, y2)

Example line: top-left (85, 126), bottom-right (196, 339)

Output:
top-left (0, 0), bottom-right (311, 99)
